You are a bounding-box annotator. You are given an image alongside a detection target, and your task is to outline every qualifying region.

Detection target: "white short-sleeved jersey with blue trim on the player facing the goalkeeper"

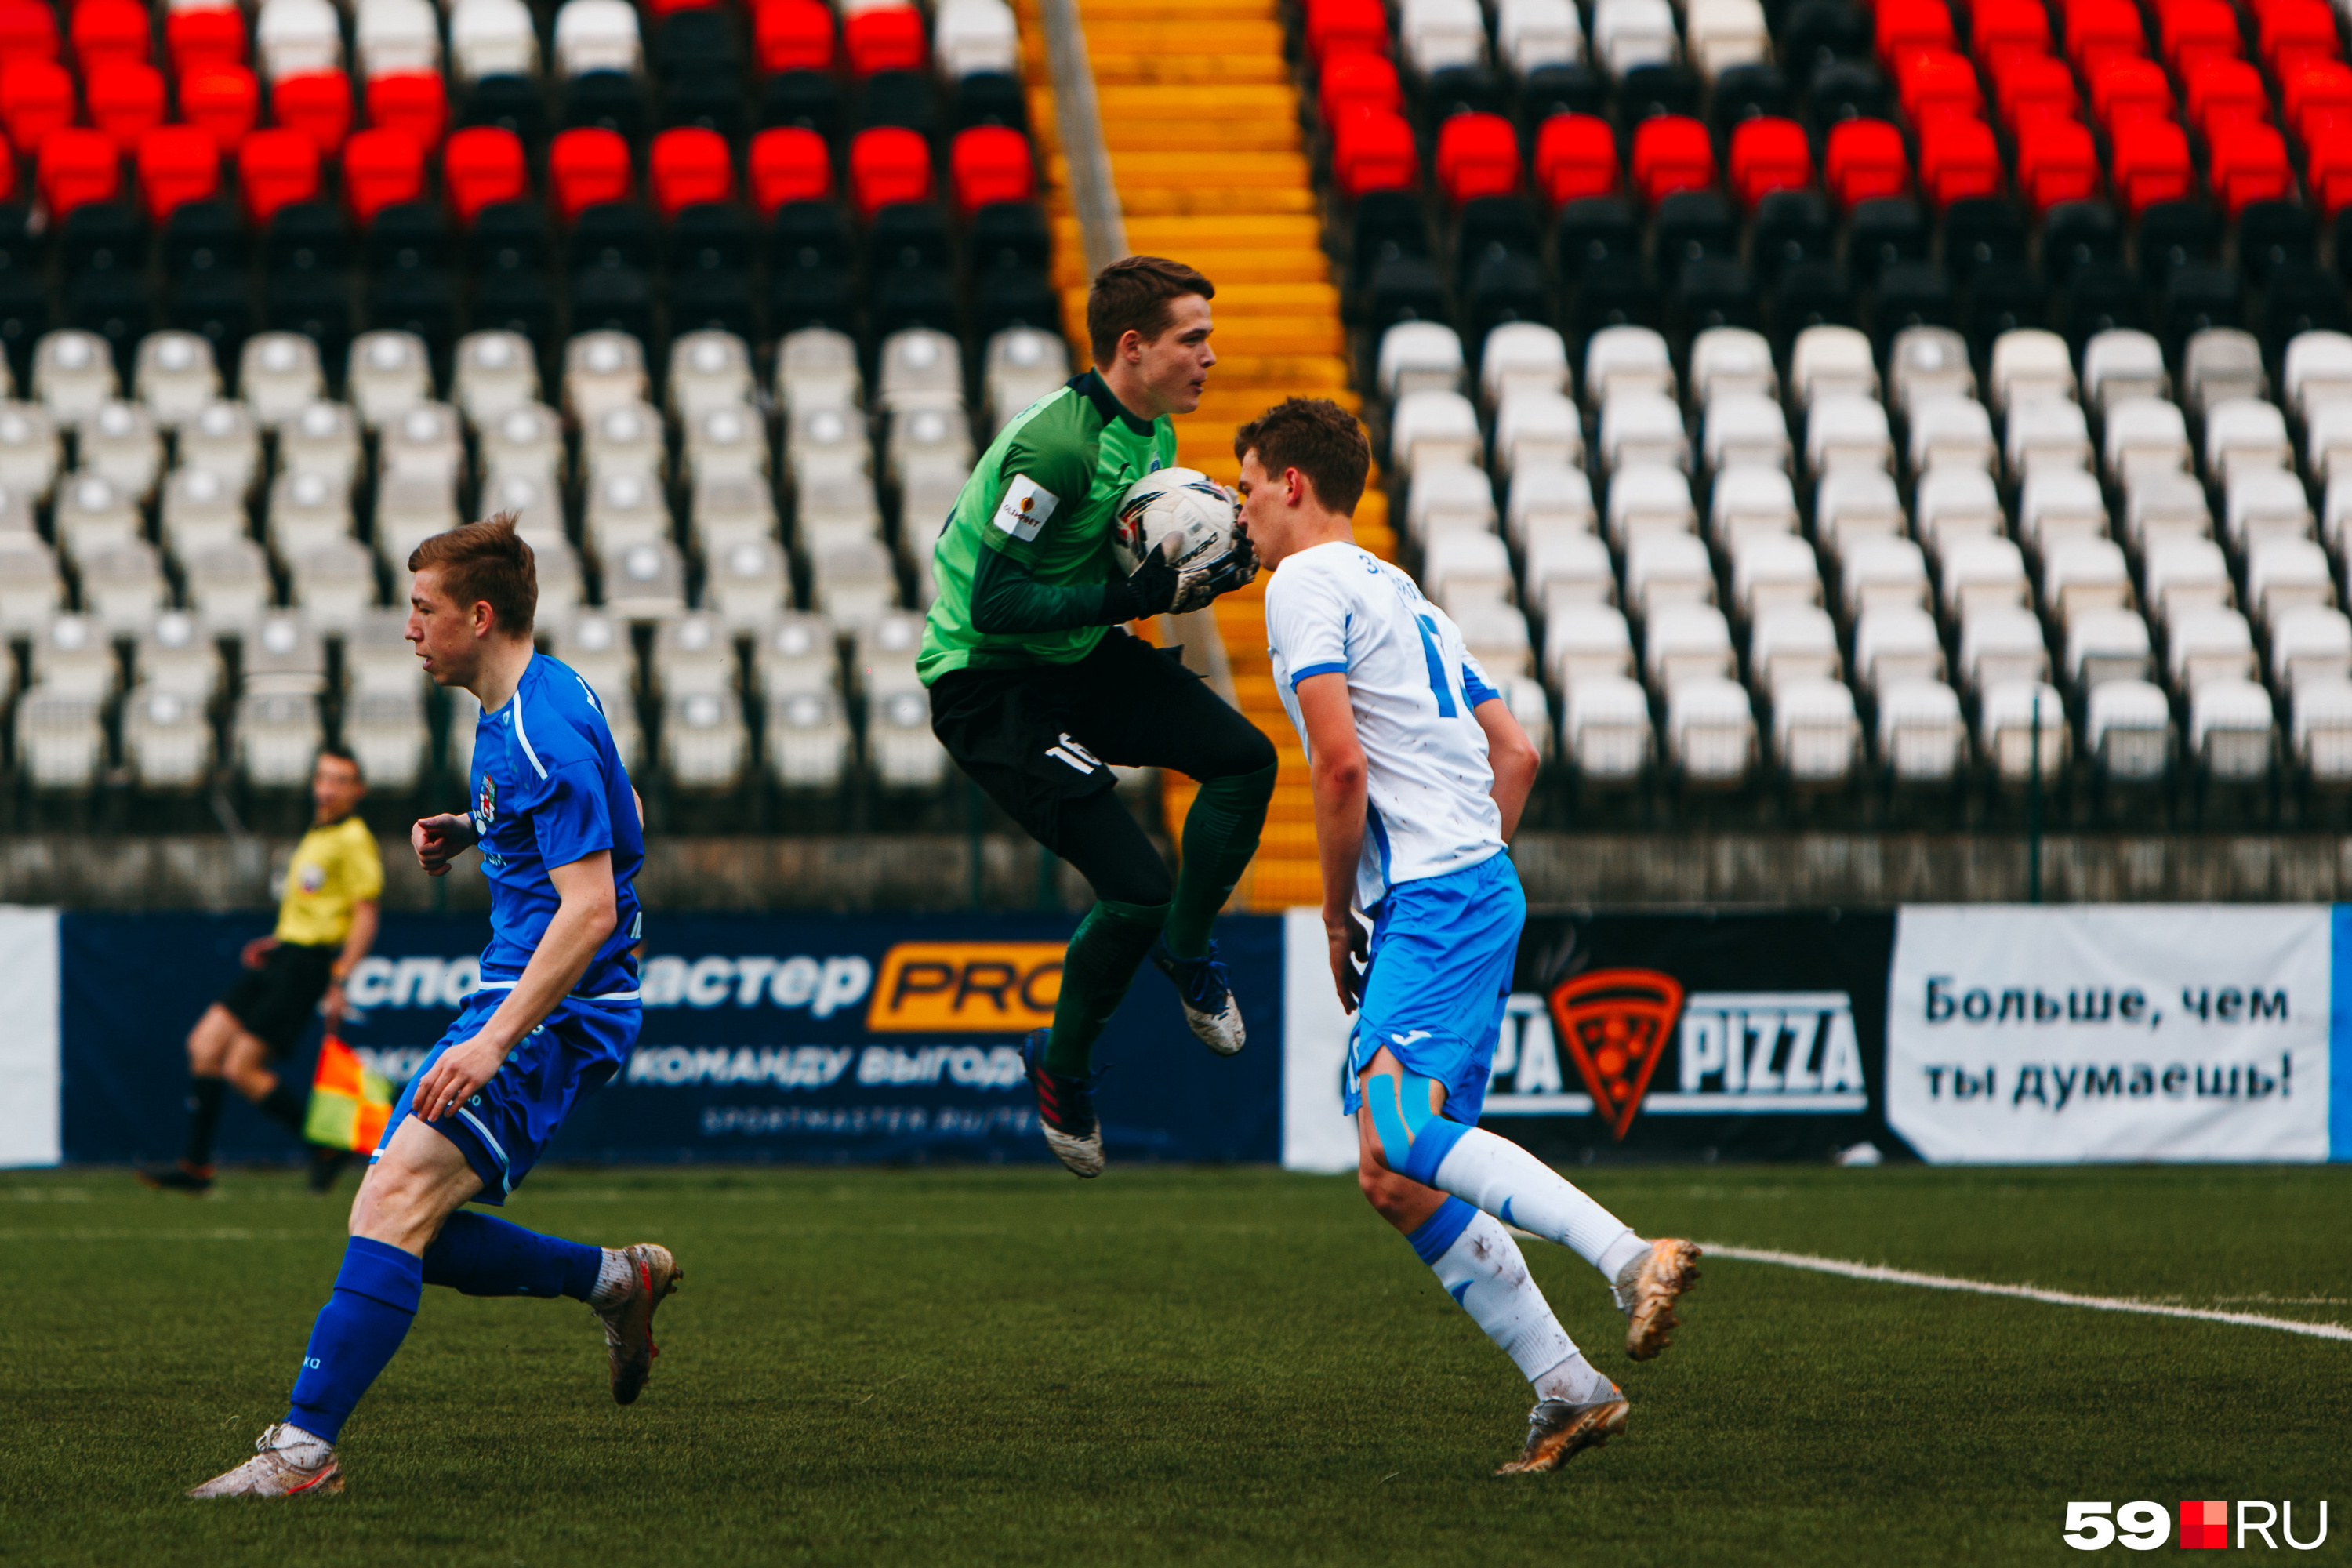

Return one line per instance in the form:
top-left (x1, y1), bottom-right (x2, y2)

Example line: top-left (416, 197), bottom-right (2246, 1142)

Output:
top-left (1265, 541), bottom-right (1503, 912)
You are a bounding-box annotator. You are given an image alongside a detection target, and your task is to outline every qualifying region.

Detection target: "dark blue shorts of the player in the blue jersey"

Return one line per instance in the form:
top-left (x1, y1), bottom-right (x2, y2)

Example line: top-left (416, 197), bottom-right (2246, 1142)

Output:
top-left (367, 989), bottom-right (642, 1203)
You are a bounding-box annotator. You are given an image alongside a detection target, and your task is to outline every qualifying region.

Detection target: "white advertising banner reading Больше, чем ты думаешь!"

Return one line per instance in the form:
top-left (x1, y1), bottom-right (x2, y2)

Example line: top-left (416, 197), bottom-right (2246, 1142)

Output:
top-left (1886, 905), bottom-right (2333, 1163)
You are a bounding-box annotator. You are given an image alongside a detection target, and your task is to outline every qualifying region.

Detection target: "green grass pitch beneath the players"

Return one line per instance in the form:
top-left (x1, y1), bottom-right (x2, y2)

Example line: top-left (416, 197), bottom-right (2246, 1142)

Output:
top-left (0, 1166), bottom-right (2352, 1568)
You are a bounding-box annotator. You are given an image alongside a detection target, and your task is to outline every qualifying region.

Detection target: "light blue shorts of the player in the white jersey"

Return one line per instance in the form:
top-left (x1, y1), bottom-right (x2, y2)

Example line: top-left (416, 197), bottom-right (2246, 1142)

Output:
top-left (1341, 853), bottom-right (1526, 1126)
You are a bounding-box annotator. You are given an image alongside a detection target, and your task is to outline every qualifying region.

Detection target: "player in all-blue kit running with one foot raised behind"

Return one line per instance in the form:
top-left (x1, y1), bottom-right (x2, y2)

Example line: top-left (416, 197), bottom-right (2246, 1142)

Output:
top-left (188, 515), bottom-right (680, 1497)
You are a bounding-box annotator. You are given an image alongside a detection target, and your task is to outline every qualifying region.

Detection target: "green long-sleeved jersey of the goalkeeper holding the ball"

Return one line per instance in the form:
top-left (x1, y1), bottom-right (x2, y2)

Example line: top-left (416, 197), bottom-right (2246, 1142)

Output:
top-left (917, 372), bottom-right (1176, 687)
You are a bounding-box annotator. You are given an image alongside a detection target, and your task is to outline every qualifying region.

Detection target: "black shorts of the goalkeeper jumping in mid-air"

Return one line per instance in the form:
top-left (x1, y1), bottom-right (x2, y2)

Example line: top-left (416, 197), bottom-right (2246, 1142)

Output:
top-left (931, 628), bottom-right (1275, 858)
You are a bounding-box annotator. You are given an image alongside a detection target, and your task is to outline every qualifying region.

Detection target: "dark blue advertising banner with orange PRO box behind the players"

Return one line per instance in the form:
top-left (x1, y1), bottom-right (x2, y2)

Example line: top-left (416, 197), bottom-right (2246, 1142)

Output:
top-left (59, 914), bottom-right (1282, 1161)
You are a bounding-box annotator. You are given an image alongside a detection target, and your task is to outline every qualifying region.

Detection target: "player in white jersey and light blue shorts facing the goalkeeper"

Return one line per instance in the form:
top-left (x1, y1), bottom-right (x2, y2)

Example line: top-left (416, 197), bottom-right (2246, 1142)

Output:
top-left (1232, 397), bottom-right (1698, 1474)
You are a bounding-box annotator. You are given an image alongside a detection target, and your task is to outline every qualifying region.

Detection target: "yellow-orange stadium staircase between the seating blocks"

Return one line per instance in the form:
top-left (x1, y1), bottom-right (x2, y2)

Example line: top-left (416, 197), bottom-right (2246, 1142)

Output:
top-left (1021, 0), bottom-right (1395, 909)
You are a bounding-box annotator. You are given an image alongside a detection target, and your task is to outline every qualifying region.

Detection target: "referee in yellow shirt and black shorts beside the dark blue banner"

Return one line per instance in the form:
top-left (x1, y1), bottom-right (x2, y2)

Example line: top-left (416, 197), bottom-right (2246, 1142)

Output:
top-left (139, 746), bottom-right (383, 1194)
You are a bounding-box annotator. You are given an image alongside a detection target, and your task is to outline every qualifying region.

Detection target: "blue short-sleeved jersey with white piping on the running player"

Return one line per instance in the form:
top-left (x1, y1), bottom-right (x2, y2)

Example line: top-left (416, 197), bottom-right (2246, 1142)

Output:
top-left (470, 654), bottom-right (644, 999)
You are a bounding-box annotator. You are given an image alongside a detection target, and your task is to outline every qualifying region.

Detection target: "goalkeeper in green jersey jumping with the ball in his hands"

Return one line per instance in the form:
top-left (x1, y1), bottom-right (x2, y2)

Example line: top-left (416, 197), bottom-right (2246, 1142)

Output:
top-left (922, 256), bottom-right (1277, 1175)
